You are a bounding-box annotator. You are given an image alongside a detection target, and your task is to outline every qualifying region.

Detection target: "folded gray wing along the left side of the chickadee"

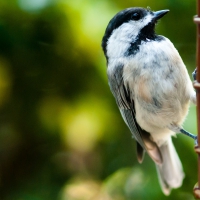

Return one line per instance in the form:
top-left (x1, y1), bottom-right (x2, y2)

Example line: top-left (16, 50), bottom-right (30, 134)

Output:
top-left (108, 64), bottom-right (162, 163)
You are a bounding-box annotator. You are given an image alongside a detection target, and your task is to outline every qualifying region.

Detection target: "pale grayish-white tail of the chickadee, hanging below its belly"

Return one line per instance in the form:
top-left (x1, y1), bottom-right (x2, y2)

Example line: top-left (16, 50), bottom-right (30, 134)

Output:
top-left (156, 137), bottom-right (185, 195)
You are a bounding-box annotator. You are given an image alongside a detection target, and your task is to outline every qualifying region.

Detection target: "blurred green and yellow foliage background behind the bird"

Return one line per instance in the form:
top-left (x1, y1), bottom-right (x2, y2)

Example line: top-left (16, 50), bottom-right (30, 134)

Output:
top-left (0, 0), bottom-right (197, 200)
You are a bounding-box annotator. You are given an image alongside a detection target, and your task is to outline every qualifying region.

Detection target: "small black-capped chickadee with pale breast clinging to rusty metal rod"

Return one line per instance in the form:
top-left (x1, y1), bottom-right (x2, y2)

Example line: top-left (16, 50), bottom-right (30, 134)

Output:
top-left (102, 7), bottom-right (196, 195)
